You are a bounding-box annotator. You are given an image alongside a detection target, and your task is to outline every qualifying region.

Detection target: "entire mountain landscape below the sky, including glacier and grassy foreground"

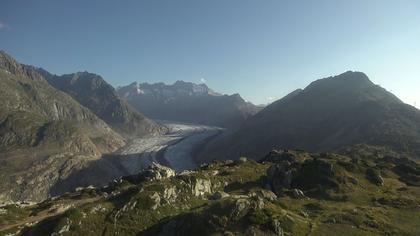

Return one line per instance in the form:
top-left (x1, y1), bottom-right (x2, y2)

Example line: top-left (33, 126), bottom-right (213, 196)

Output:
top-left (0, 51), bottom-right (420, 236)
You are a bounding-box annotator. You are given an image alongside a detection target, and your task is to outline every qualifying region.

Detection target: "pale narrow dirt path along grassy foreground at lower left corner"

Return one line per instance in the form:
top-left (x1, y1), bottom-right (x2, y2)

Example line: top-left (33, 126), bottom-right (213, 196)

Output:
top-left (0, 197), bottom-right (101, 233)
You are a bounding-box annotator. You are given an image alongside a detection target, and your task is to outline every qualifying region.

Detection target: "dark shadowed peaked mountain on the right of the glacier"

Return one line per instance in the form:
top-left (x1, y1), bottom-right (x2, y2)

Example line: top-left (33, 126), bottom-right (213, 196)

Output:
top-left (201, 72), bottom-right (420, 160)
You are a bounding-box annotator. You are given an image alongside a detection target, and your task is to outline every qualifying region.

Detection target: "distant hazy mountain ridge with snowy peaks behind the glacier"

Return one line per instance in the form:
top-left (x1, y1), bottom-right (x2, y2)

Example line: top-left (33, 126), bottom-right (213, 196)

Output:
top-left (117, 81), bottom-right (260, 128)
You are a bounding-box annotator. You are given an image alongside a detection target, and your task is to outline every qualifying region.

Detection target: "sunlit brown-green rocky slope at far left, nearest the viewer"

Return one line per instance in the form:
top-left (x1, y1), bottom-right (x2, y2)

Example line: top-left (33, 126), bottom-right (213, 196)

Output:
top-left (0, 52), bottom-right (125, 202)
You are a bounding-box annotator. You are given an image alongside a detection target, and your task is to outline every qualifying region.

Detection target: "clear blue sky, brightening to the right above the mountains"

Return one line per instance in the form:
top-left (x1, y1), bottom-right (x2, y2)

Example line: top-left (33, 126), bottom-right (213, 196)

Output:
top-left (0, 0), bottom-right (420, 107)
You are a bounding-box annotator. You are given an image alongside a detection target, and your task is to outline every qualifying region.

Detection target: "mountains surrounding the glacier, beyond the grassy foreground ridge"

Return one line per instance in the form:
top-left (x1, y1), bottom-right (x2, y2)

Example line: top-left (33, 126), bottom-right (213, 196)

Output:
top-left (0, 52), bottom-right (420, 207)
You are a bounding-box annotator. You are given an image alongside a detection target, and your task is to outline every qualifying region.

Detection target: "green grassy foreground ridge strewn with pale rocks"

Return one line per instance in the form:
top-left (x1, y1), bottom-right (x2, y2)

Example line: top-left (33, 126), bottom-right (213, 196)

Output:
top-left (0, 146), bottom-right (420, 236)
